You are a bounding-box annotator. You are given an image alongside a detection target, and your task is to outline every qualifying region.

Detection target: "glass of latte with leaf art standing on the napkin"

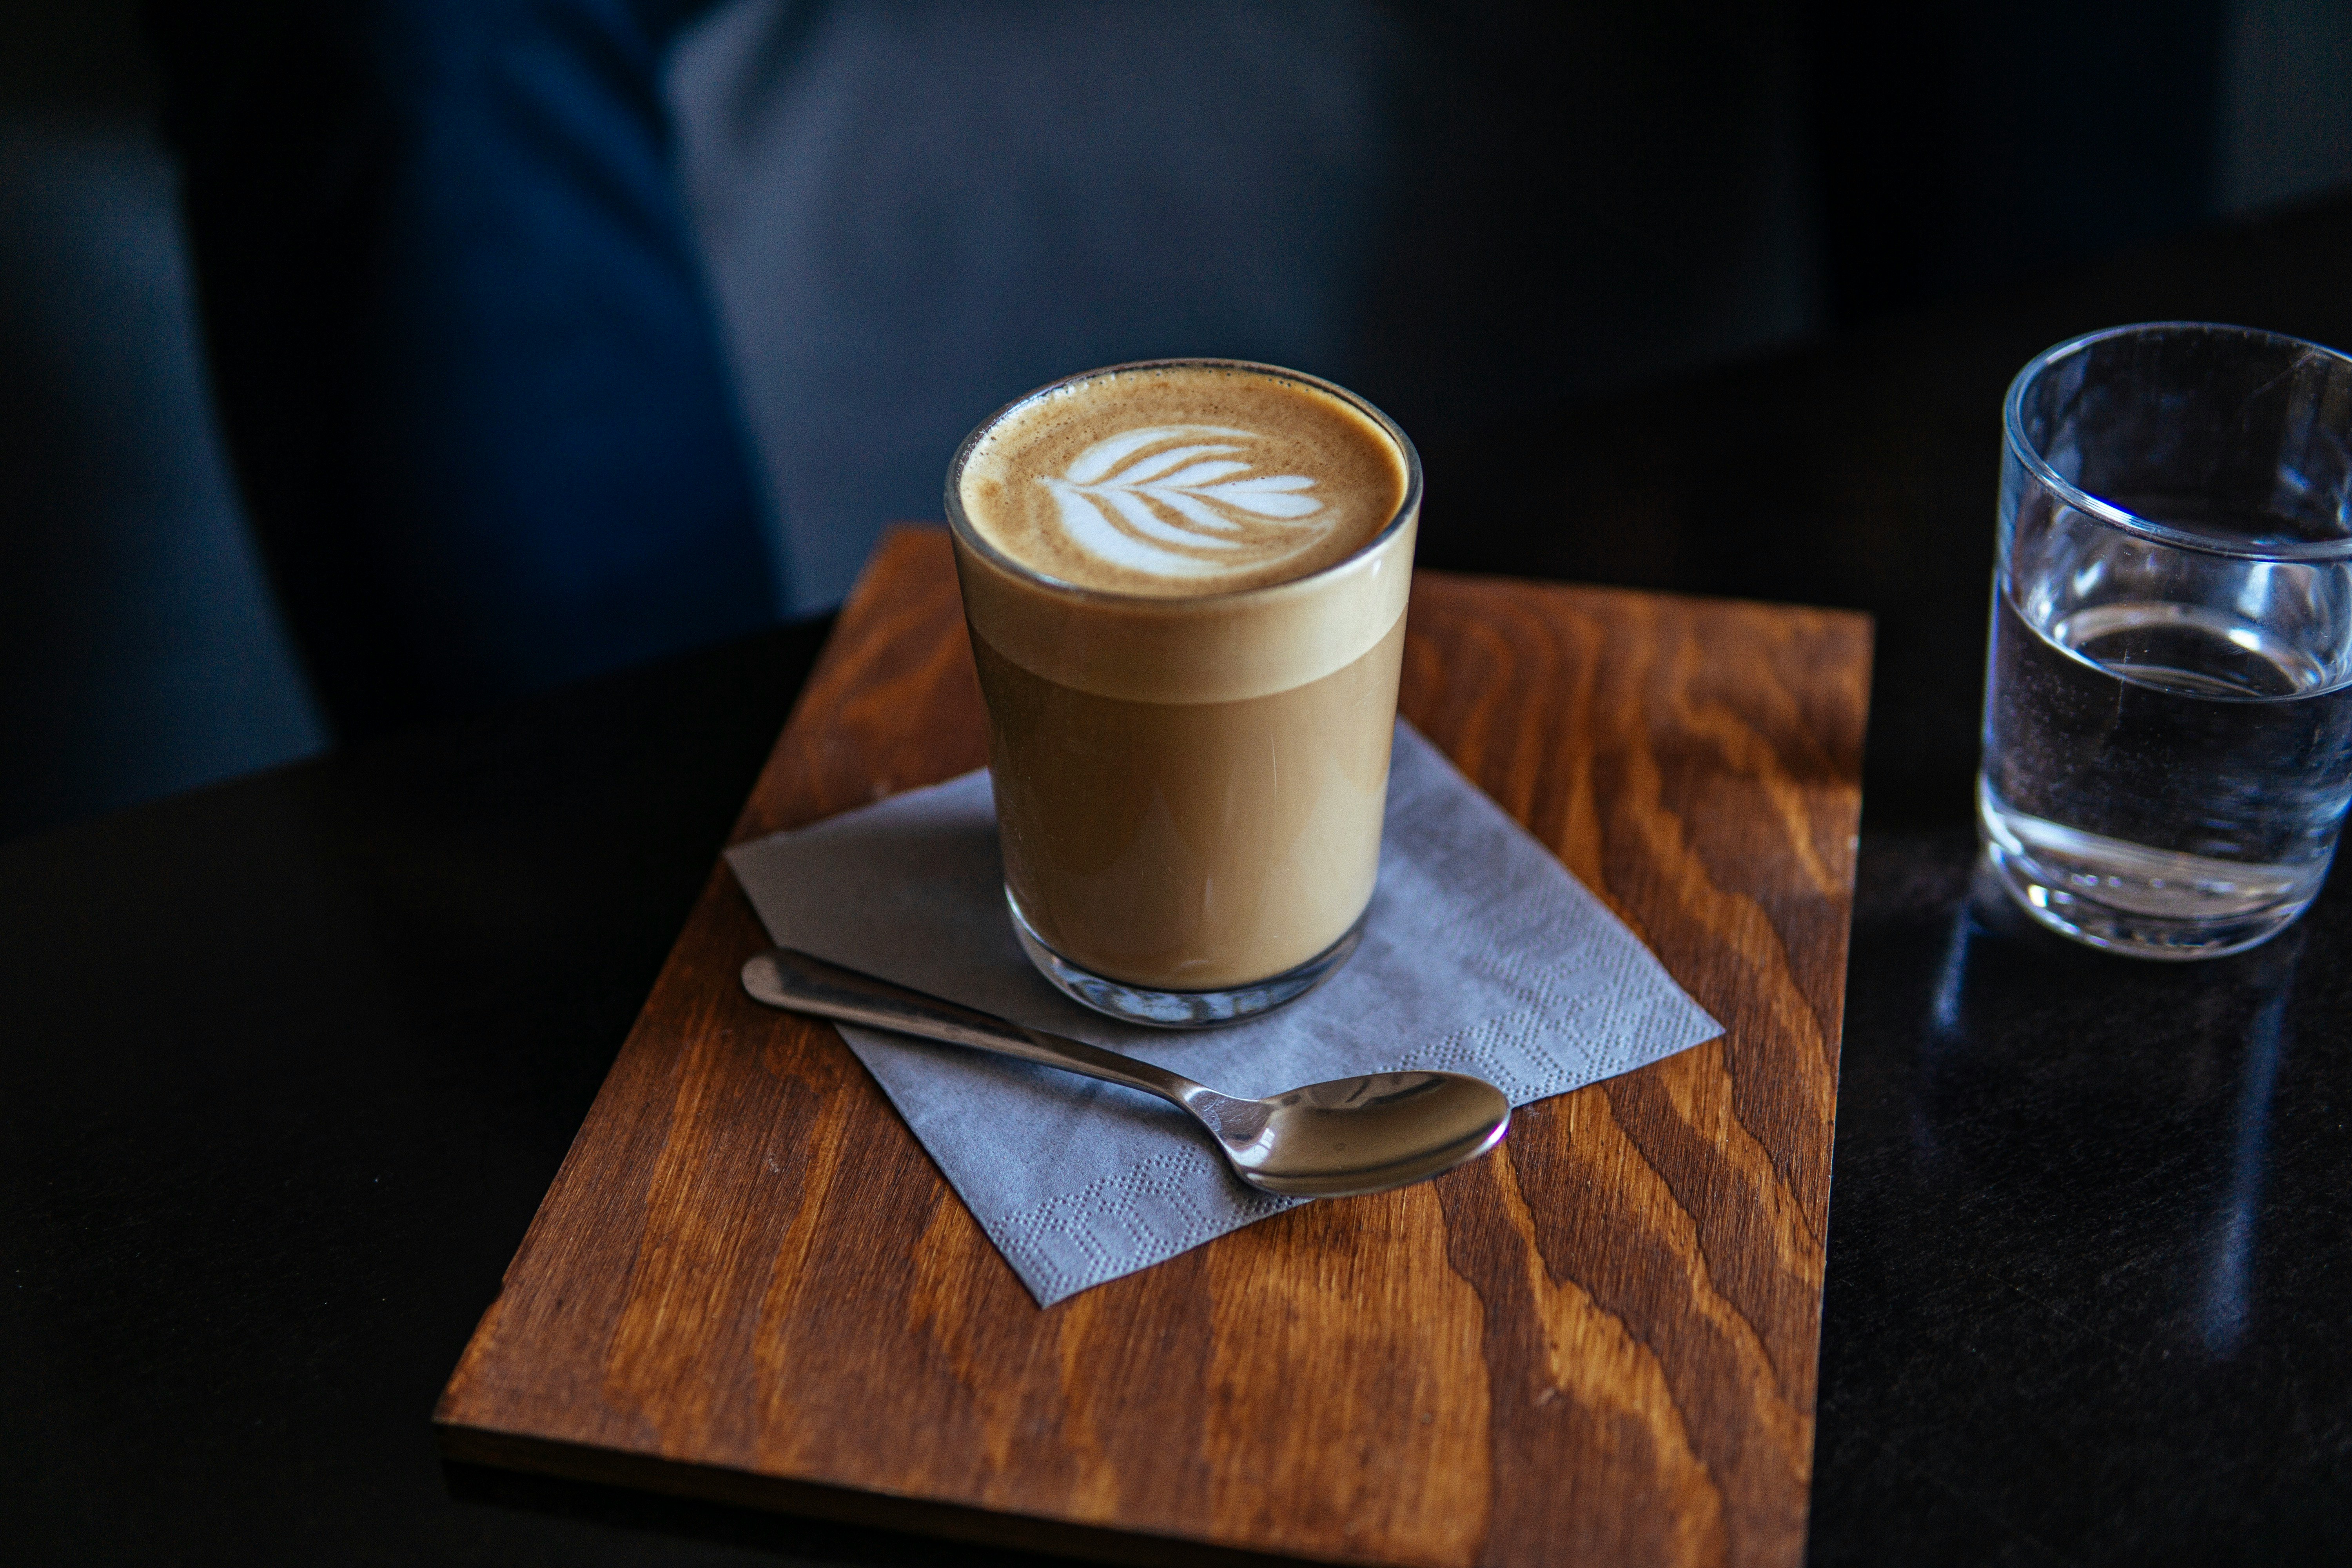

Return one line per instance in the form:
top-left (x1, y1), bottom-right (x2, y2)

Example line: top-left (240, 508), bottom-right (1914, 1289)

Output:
top-left (948, 360), bottom-right (1421, 1027)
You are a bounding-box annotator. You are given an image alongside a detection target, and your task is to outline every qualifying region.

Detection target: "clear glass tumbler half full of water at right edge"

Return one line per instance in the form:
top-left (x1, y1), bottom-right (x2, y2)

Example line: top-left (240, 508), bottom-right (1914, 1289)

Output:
top-left (1976, 322), bottom-right (2352, 959)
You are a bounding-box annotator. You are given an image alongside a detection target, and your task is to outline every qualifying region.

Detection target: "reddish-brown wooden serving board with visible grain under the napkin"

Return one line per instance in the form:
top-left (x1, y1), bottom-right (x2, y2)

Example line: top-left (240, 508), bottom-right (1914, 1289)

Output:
top-left (435, 529), bottom-right (1870, 1568)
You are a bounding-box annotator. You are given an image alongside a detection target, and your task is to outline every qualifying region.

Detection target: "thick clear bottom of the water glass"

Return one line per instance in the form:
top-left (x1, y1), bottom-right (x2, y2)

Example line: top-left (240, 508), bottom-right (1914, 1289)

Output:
top-left (1978, 792), bottom-right (2324, 962)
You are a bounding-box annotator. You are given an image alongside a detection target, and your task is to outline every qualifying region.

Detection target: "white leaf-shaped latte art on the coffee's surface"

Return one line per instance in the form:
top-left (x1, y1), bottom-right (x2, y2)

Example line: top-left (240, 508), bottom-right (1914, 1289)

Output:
top-left (1040, 425), bottom-right (1329, 576)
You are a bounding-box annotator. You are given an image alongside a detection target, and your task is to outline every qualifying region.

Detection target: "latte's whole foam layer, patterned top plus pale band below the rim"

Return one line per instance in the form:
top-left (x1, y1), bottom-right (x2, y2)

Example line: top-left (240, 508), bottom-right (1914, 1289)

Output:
top-left (950, 362), bottom-right (1418, 703)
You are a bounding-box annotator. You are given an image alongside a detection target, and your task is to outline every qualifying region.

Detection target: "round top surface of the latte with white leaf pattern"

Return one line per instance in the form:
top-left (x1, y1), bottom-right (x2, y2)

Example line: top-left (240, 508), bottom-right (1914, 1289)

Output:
top-left (957, 365), bottom-right (1406, 597)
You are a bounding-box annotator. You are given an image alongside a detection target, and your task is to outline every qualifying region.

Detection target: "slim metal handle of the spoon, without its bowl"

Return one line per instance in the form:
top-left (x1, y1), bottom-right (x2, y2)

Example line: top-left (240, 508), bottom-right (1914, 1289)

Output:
top-left (743, 947), bottom-right (1207, 1114)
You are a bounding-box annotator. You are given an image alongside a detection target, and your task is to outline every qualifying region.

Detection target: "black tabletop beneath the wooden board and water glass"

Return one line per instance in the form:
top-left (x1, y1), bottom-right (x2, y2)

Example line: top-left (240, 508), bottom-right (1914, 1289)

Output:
top-left (14, 190), bottom-right (2352, 1563)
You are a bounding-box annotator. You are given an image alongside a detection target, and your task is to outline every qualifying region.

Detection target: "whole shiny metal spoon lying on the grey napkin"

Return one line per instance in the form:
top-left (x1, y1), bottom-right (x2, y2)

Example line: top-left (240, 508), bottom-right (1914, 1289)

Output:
top-left (743, 947), bottom-right (1510, 1199)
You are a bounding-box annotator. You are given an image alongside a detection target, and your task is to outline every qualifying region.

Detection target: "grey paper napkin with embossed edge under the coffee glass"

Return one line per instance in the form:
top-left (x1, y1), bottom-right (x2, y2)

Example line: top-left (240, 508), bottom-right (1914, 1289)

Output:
top-left (727, 724), bottom-right (1722, 1307)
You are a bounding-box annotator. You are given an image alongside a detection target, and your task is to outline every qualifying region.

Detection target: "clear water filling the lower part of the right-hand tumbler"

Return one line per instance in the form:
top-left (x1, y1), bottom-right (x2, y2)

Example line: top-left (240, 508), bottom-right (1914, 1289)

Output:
top-left (1978, 505), bottom-right (2352, 957)
